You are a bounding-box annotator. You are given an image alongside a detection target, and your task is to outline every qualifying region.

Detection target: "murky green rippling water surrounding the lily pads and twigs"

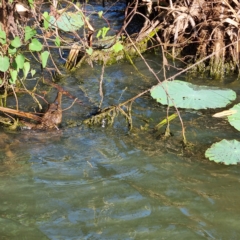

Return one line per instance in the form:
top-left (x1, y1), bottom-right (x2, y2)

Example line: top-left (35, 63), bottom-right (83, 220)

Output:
top-left (0, 0), bottom-right (240, 240)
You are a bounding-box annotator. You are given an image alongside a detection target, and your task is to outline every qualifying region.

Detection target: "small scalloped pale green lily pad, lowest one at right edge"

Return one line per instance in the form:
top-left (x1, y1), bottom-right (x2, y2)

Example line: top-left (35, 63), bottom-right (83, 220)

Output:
top-left (205, 139), bottom-right (240, 165)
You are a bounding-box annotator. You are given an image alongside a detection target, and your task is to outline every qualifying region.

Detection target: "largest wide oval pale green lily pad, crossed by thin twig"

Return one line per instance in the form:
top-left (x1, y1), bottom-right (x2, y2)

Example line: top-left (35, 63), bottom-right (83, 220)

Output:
top-left (151, 80), bottom-right (236, 110)
